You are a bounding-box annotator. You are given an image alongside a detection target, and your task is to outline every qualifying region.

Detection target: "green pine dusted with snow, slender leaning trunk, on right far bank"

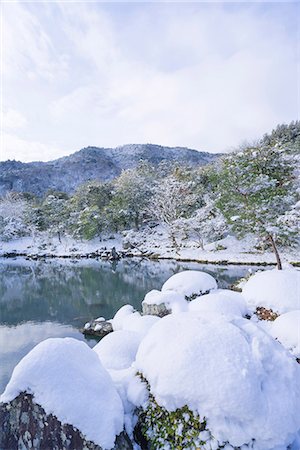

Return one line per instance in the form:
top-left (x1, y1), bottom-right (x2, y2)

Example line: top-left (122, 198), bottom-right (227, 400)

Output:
top-left (215, 142), bottom-right (297, 269)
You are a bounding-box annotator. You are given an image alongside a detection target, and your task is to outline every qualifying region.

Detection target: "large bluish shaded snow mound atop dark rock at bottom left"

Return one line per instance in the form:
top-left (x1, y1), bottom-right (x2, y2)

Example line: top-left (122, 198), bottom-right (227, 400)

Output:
top-left (0, 338), bottom-right (124, 449)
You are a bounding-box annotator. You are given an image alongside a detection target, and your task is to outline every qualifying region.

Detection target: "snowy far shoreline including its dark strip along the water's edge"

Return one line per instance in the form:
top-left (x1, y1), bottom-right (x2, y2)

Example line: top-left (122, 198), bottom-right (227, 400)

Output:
top-left (0, 230), bottom-right (300, 267)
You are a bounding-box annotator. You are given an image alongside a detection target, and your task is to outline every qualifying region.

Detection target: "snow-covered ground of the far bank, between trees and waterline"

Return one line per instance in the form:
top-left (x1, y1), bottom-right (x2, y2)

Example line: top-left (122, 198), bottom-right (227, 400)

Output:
top-left (0, 226), bottom-right (300, 264)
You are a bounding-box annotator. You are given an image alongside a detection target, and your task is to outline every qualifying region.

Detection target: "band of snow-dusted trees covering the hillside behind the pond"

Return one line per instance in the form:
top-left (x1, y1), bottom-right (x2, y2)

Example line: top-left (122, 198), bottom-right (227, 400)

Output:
top-left (0, 121), bottom-right (300, 265)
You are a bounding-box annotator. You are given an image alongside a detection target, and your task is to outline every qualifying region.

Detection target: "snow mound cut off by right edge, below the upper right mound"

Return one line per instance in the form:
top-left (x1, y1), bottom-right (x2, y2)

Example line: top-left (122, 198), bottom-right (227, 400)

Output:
top-left (270, 310), bottom-right (300, 358)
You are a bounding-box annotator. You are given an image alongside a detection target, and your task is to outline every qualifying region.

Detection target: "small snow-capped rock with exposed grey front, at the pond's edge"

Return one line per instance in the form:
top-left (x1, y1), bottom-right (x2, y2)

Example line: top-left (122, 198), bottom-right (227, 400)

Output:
top-left (142, 289), bottom-right (187, 317)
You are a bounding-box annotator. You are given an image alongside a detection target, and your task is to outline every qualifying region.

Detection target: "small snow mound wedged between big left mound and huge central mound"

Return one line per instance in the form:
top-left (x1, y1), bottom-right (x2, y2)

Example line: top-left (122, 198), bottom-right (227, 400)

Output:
top-left (93, 330), bottom-right (142, 370)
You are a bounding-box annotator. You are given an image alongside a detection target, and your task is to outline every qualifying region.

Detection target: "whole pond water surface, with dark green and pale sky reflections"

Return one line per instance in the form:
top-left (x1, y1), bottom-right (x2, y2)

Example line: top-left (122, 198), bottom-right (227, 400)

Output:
top-left (0, 258), bottom-right (264, 393)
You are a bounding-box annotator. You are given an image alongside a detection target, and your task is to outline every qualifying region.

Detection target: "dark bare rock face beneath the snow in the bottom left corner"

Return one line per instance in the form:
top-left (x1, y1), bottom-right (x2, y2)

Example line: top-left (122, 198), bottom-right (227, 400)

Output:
top-left (0, 392), bottom-right (133, 450)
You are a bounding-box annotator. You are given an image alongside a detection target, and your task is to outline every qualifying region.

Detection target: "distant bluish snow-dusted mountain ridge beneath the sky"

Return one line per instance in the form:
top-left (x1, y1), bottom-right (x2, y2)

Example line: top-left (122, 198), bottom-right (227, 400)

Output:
top-left (0, 144), bottom-right (220, 195)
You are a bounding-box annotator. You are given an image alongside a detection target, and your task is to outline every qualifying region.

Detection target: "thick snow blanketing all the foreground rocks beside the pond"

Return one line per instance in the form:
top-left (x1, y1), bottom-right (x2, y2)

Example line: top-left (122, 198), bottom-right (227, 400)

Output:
top-left (0, 268), bottom-right (300, 450)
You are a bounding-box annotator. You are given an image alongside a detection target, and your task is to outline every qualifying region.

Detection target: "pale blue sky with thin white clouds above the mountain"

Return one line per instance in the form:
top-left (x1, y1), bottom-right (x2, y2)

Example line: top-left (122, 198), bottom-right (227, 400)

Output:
top-left (0, 0), bottom-right (300, 162)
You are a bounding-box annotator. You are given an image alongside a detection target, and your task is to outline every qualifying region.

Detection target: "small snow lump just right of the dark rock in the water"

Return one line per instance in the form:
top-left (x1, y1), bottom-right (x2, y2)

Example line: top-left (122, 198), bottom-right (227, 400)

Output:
top-left (111, 305), bottom-right (159, 336)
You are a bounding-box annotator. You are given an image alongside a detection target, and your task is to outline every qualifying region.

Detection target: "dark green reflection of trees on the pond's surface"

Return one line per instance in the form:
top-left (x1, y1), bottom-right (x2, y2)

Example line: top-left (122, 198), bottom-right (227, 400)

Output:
top-left (0, 259), bottom-right (262, 326)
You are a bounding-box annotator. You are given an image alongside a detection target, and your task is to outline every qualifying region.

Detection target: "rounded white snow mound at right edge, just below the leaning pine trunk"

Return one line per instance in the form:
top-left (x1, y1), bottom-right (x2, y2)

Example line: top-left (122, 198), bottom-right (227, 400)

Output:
top-left (242, 269), bottom-right (300, 314)
